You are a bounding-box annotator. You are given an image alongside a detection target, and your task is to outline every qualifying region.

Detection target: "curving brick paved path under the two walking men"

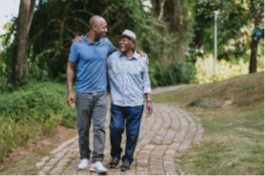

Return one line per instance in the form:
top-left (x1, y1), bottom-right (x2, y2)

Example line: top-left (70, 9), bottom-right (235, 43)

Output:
top-left (36, 85), bottom-right (203, 175)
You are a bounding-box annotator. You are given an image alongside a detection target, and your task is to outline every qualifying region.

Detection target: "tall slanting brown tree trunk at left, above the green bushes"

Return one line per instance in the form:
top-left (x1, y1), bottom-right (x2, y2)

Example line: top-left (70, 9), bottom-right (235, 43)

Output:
top-left (12, 0), bottom-right (35, 84)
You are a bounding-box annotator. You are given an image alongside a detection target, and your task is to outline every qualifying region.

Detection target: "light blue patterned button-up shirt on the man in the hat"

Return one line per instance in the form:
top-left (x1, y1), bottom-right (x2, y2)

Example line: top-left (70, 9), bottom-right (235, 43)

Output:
top-left (107, 51), bottom-right (151, 107)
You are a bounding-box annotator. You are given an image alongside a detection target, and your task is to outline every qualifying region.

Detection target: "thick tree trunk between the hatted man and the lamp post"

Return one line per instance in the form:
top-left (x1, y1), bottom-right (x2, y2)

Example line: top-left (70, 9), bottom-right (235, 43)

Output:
top-left (151, 0), bottom-right (194, 63)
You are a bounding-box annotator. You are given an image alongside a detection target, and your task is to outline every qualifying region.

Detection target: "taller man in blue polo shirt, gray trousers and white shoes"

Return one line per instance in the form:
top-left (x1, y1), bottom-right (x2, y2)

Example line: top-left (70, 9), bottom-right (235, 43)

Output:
top-left (67, 16), bottom-right (116, 174)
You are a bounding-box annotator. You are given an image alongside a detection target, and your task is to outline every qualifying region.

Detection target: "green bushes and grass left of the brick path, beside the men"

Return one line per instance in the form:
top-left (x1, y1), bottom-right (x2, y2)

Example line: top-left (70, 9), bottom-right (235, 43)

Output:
top-left (0, 82), bottom-right (76, 161)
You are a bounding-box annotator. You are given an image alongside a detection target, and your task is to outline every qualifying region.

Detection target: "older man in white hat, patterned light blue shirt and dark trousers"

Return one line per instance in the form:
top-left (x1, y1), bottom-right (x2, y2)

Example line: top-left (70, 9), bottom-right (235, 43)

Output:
top-left (107, 30), bottom-right (152, 172)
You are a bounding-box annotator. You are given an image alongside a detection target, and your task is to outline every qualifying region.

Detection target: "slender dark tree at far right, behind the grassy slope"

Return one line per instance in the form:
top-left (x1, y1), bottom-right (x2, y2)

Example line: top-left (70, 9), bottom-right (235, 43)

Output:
top-left (249, 0), bottom-right (264, 73)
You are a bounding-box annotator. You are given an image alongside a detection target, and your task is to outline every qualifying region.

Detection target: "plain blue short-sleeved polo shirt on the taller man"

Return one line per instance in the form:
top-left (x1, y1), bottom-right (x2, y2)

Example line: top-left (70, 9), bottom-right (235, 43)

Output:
top-left (68, 37), bottom-right (116, 93)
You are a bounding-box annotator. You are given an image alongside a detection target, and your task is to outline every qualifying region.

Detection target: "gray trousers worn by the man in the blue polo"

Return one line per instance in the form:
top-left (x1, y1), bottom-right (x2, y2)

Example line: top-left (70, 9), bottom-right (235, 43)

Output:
top-left (76, 92), bottom-right (107, 162)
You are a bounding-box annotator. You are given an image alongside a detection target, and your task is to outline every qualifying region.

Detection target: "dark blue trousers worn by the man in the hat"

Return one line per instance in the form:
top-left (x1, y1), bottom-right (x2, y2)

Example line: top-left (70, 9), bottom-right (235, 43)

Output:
top-left (110, 104), bottom-right (144, 164)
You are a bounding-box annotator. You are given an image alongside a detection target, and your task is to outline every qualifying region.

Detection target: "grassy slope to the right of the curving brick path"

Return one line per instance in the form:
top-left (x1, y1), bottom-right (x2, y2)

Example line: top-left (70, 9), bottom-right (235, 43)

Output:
top-left (153, 72), bottom-right (264, 175)
